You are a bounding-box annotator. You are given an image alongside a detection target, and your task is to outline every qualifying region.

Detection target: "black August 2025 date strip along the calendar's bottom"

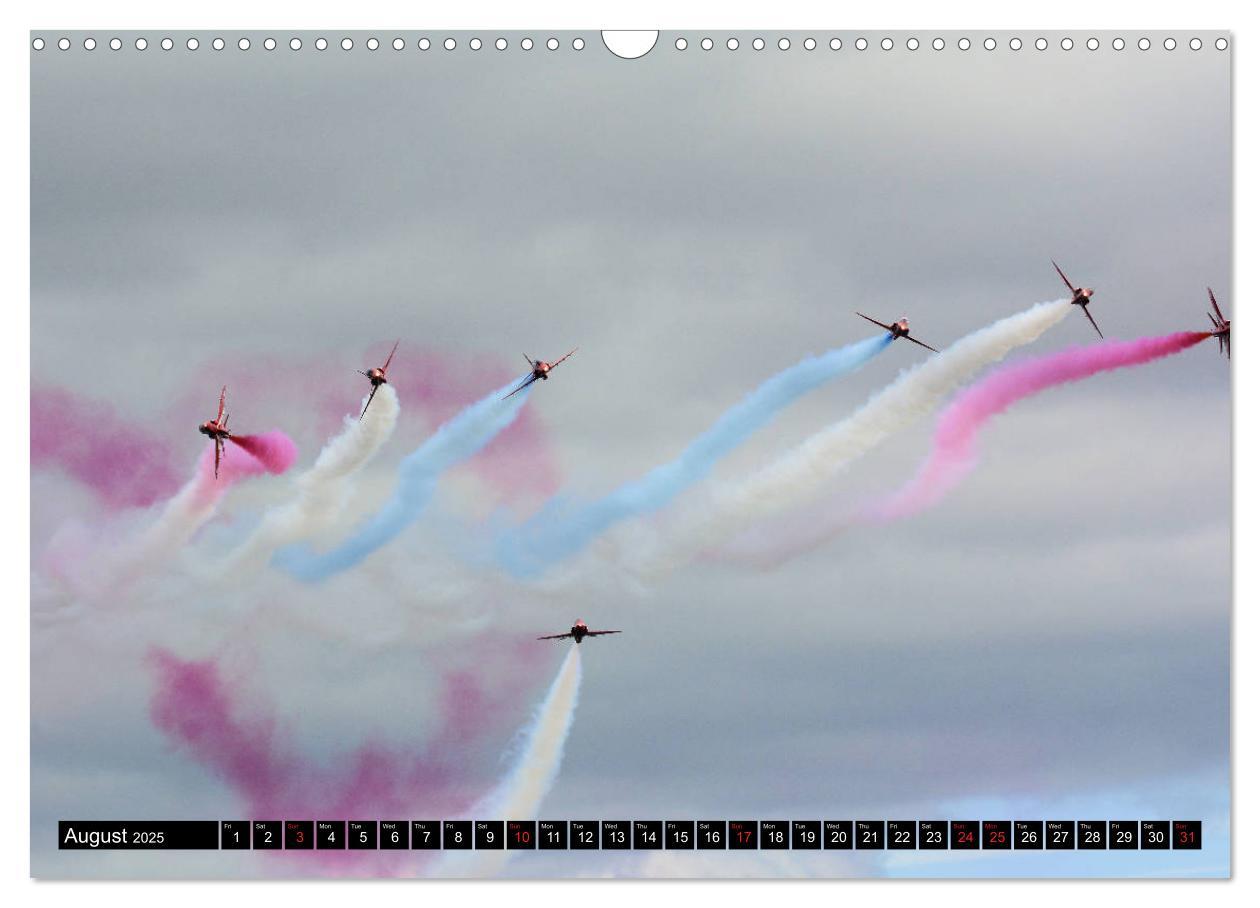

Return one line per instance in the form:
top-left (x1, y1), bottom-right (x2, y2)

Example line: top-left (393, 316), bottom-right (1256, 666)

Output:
top-left (57, 820), bottom-right (1203, 851)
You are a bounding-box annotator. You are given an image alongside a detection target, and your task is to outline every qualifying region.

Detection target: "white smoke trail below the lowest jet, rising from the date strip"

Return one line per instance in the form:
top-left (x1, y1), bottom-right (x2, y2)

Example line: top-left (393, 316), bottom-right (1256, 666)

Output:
top-left (432, 644), bottom-right (582, 878)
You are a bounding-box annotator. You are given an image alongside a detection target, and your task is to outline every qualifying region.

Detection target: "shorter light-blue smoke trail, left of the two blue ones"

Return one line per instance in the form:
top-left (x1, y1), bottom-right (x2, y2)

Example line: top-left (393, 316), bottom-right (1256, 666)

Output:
top-left (271, 377), bottom-right (533, 583)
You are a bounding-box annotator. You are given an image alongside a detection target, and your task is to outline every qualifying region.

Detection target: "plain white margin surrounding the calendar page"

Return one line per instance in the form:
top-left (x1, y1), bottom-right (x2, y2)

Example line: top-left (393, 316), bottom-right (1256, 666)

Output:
top-left (0, 0), bottom-right (1260, 908)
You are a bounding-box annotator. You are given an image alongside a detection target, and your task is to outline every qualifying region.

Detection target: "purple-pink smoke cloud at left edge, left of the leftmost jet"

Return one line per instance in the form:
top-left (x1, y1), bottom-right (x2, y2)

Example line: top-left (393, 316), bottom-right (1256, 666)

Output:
top-left (30, 388), bottom-right (180, 509)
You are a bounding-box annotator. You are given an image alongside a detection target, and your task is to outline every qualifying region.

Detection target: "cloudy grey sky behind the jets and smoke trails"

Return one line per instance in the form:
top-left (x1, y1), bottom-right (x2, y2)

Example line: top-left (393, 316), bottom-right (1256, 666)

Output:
top-left (32, 33), bottom-right (1232, 875)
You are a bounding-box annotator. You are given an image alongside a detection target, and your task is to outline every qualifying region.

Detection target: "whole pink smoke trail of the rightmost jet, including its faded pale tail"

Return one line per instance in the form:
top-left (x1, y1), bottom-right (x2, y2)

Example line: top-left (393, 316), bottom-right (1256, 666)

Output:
top-left (712, 331), bottom-right (1211, 570)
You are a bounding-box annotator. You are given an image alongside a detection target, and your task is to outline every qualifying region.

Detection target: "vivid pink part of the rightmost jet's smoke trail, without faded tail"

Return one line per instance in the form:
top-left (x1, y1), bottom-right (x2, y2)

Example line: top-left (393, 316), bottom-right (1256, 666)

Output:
top-left (862, 331), bottom-right (1212, 523)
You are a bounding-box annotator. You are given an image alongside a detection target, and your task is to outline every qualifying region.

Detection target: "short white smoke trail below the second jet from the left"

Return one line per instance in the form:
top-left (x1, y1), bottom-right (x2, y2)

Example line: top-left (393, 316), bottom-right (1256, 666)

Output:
top-left (214, 384), bottom-right (401, 577)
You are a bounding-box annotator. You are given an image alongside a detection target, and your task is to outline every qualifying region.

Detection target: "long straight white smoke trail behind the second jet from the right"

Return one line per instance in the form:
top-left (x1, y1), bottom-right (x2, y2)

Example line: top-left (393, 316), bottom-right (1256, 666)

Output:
top-left (629, 300), bottom-right (1072, 577)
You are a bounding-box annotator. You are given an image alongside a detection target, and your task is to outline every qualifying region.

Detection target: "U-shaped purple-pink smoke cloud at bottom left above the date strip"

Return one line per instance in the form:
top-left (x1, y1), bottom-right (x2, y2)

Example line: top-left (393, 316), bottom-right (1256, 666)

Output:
top-left (150, 629), bottom-right (541, 875)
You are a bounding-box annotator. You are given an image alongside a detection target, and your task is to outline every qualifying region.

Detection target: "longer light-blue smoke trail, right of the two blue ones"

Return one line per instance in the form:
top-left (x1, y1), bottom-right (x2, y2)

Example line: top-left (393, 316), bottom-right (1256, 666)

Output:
top-left (495, 334), bottom-right (893, 577)
